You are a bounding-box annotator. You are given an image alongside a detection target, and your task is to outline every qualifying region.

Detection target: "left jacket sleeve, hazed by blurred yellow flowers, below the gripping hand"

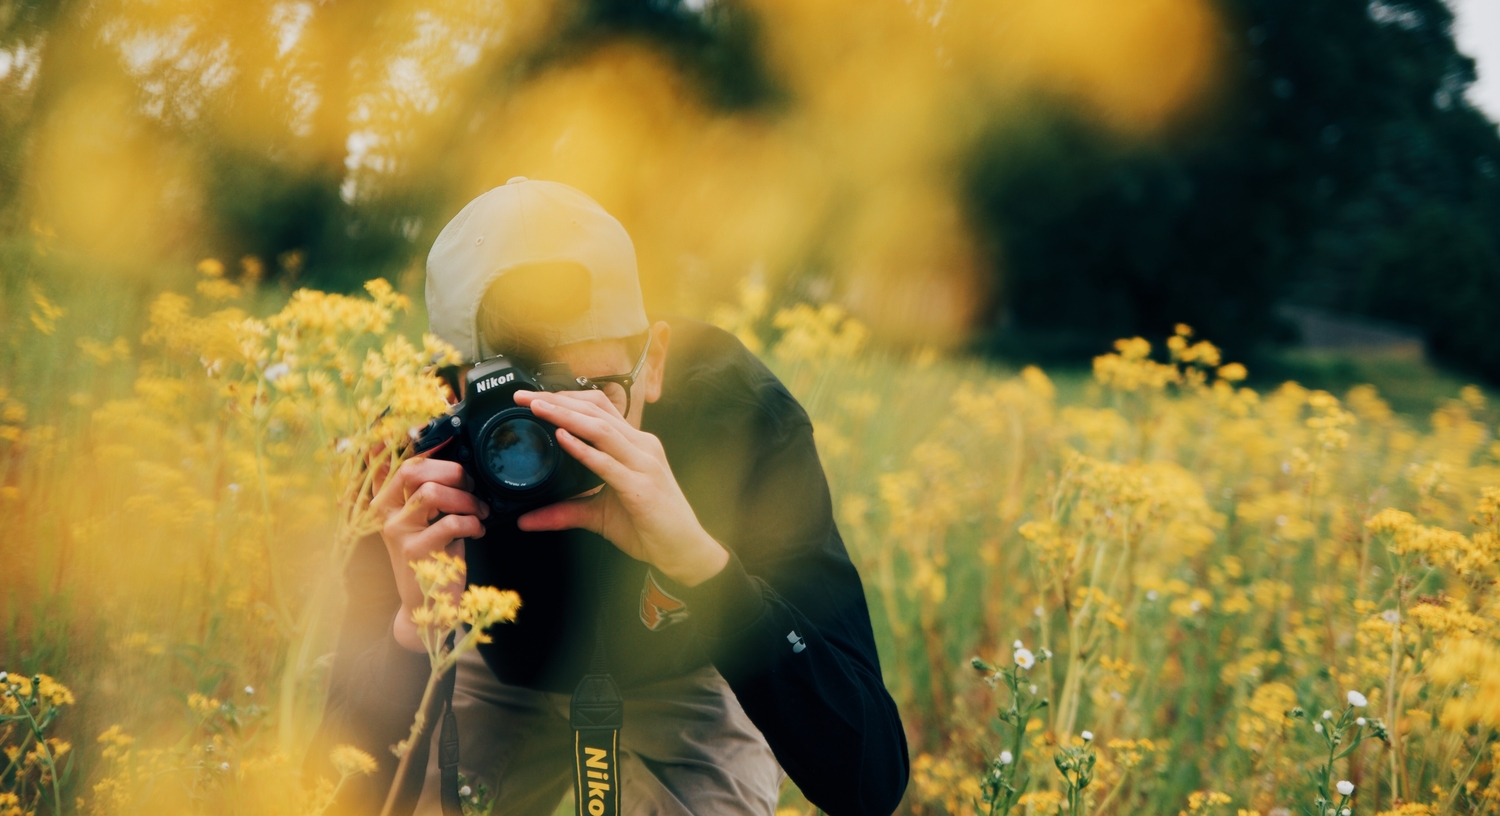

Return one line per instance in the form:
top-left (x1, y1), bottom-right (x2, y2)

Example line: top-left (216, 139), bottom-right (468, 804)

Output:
top-left (305, 536), bottom-right (431, 815)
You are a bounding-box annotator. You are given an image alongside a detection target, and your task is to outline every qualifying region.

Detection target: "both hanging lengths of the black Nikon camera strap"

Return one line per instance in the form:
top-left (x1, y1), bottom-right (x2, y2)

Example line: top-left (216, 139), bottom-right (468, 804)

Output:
top-left (438, 542), bottom-right (626, 816)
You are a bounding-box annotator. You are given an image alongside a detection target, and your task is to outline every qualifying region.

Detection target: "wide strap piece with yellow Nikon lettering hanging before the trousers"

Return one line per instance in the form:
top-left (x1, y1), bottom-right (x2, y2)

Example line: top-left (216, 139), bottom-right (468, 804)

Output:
top-left (569, 542), bottom-right (626, 816)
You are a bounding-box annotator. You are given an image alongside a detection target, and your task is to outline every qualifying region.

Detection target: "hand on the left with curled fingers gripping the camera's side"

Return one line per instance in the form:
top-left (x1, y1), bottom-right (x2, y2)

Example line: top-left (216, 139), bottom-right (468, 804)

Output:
top-left (374, 458), bottom-right (489, 651)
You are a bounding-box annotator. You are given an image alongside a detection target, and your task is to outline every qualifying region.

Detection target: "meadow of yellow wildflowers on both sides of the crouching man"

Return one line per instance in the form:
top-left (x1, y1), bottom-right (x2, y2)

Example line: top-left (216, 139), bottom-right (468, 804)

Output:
top-left (0, 248), bottom-right (1500, 816)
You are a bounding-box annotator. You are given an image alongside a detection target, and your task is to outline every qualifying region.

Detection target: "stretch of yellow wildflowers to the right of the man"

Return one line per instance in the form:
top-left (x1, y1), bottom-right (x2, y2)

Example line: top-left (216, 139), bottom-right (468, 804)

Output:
top-left (729, 297), bottom-right (1500, 813)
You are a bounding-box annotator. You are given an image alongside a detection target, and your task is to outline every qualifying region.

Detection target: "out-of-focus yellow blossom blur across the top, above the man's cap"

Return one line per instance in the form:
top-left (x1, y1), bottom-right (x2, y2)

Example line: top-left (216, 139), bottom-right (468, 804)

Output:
top-left (27, 0), bottom-right (1220, 339)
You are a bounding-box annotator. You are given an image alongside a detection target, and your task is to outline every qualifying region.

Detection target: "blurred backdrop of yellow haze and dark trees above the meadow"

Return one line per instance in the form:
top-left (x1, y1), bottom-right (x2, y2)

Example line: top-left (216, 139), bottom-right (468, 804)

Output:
top-left (0, 0), bottom-right (1500, 387)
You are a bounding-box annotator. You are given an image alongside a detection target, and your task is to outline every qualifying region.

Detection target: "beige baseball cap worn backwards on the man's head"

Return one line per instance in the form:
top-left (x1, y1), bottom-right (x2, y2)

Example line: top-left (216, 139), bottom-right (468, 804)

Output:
top-left (428, 176), bottom-right (651, 363)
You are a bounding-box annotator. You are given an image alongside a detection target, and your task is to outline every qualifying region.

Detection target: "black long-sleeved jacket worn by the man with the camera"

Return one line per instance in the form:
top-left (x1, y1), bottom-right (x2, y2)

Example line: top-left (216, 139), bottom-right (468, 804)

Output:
top-left (309, 321), bottom-right (908, 816)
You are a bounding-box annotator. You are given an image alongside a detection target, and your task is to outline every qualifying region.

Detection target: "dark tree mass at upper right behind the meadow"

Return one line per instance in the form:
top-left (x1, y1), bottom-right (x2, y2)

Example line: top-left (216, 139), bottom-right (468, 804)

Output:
top-left (971, 0), bottom-right (1500, 378)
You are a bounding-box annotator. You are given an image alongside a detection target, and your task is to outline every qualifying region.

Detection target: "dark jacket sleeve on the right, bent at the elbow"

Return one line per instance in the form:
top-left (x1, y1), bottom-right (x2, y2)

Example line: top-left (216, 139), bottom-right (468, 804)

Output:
top-left (674, 405), bottom-right (909, 816)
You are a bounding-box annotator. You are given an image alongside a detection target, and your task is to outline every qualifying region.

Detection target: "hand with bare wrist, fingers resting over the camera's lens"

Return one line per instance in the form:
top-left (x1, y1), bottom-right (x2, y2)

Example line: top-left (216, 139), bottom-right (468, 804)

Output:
top-left (516, 392), bottom-right (729, 587)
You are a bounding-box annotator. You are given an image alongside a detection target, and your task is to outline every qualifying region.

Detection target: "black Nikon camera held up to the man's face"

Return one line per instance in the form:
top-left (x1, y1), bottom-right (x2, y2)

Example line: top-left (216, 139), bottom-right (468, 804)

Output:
top-left (416, 357), bottom-right (603, 516)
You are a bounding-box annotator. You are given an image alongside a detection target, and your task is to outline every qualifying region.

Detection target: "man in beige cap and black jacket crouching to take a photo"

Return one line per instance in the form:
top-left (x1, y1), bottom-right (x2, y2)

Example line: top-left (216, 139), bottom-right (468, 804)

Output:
top-left (311, 177), bottom-right (908, 816)
